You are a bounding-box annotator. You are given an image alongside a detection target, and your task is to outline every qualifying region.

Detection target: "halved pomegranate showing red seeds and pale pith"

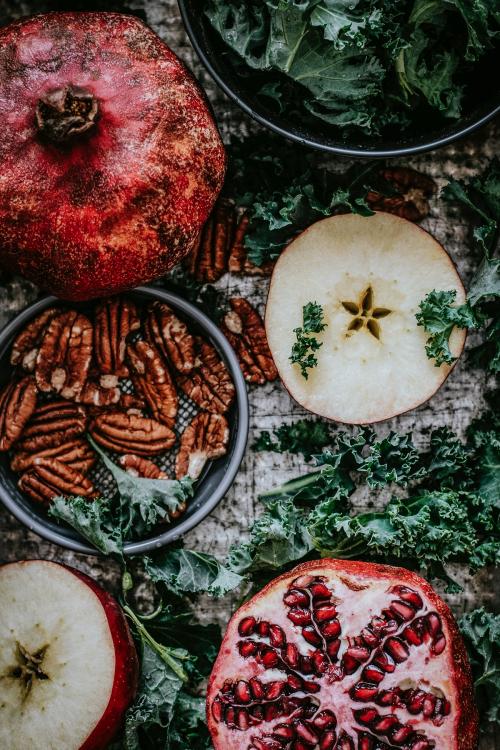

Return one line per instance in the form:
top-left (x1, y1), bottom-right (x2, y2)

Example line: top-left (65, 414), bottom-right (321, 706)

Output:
top-left (207, 560), bottom-right (477, 750)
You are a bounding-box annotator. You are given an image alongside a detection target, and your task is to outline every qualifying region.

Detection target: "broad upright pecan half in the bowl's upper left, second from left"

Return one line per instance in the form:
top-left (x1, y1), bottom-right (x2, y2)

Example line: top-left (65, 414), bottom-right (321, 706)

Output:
top-left (35, 310), bottom-right (93, 399)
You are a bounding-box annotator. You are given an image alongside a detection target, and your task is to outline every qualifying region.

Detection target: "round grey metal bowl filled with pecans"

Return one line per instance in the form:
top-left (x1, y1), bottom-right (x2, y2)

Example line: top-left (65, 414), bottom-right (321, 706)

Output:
top-left (0, 287), bottom-right (248, 554)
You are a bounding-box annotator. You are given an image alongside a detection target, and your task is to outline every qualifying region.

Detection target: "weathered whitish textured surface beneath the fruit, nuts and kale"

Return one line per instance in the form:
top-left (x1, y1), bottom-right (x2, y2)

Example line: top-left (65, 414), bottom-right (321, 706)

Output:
top-left (0, 0), bottom-right (500, 750)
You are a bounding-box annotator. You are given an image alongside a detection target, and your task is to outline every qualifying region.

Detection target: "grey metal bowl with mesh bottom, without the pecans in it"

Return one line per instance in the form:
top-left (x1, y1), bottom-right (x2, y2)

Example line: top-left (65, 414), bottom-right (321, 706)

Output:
top-left (0, 288), bottom-right (248, 554)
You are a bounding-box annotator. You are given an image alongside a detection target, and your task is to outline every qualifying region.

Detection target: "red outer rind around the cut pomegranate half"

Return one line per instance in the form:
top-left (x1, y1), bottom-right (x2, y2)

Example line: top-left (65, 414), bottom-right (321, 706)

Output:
top-left (206, 558), bottom-right (478, 750)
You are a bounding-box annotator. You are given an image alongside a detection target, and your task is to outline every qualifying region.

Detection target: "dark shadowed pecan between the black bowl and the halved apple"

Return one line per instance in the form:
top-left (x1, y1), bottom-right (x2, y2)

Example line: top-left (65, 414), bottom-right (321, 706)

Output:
top-left (366, 167), bottom-right (437, 221)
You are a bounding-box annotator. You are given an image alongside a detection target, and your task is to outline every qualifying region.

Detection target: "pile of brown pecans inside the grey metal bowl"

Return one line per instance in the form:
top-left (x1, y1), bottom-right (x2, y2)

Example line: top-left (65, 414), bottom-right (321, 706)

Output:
top-left (0, 297), bottom-right (238, 517)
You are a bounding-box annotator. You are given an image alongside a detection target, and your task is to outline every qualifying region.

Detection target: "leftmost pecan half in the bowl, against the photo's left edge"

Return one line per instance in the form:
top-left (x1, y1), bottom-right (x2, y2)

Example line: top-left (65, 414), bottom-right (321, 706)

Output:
top-left (0, 376), bottom-right (36, 451)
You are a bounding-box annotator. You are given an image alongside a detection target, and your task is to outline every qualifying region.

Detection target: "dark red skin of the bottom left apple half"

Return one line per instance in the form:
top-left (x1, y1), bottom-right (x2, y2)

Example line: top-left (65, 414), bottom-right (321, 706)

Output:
top-left (61, 565), bottom-right (139, 750)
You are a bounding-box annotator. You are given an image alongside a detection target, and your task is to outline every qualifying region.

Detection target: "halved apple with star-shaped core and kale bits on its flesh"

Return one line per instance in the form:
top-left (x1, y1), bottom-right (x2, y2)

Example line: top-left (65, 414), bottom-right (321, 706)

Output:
top-left (266, 213), bottom-right (465, 424)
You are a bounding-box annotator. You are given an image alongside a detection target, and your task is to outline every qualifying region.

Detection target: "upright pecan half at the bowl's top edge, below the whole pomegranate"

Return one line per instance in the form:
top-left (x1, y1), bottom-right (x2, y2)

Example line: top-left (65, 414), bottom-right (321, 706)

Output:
top-left (94, 297), bottom-right (140, 378)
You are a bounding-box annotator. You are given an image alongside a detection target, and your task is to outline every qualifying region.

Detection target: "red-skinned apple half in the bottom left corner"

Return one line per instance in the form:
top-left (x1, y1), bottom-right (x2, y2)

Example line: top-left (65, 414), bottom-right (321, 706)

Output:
top-left (0, 560), bottom-right (138, 750)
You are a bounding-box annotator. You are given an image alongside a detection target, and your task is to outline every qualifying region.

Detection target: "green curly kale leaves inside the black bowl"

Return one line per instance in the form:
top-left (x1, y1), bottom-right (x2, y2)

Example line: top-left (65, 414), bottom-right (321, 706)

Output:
top-left (205, 0), bottom-right (500, 135)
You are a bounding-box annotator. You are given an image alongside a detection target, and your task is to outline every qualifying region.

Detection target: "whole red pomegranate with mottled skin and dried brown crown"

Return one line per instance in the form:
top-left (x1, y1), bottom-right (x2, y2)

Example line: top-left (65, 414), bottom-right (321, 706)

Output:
top-left (0, 13), bottom-right (225, 300)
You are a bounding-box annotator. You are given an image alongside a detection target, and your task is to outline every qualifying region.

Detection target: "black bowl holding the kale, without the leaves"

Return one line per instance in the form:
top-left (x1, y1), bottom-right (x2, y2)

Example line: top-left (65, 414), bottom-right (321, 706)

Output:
top-left (178, 0), bottom-right (500, 157)
